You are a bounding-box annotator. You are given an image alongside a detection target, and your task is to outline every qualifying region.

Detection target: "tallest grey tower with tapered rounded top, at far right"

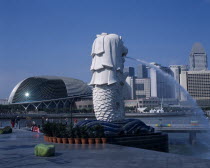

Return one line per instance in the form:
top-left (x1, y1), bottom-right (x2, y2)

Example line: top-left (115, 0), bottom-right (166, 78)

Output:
top-left (190, 43), bottom-right (208, 71)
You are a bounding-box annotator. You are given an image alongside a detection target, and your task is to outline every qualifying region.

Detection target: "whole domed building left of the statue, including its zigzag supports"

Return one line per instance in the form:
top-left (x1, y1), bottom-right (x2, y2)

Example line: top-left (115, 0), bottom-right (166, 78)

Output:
top-left (8, 76), bottom-right (92, 113)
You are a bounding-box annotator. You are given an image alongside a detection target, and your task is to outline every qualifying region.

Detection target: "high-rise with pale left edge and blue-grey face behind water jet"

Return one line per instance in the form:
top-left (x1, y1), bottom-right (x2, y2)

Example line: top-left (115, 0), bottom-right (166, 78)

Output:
top-left (150, 63), bottom-right (175, 98)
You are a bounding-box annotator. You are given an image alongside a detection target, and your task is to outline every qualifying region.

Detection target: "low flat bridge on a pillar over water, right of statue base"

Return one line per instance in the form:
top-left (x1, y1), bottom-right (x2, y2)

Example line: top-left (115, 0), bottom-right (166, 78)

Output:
top-left (148, 124), bottom-right (210, 145)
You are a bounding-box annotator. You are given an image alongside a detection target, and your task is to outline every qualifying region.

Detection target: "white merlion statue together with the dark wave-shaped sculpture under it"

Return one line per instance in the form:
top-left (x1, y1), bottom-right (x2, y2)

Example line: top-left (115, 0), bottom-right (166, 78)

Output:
top-left (76, 33), bottom-right (154, 137)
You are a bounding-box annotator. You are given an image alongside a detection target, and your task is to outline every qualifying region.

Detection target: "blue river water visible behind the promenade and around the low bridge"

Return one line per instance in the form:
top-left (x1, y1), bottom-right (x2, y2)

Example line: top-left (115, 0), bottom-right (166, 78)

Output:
top-left (0, 116), bottom-right (210, 159)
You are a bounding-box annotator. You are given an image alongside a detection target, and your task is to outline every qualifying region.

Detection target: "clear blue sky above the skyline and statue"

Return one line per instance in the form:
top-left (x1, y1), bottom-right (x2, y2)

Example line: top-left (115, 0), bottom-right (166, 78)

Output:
top-left (0, 0), bottom-right (210, 98)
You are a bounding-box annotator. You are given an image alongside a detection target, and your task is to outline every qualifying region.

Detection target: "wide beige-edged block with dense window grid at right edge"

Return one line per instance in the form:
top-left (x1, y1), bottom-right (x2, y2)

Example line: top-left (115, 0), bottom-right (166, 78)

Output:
top-left (180, 71), bottom-right (210, 107)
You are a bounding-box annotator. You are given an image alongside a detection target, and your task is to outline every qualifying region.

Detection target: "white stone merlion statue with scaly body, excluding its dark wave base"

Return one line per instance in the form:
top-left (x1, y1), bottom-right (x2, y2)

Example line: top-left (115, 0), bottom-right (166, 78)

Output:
top-left (90, 33), bottom-right (128, 122)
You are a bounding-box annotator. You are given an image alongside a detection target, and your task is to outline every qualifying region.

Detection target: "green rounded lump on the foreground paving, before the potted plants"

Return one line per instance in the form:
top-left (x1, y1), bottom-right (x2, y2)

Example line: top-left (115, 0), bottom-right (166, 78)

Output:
top-left (34, 144), bottom-right (55, 157)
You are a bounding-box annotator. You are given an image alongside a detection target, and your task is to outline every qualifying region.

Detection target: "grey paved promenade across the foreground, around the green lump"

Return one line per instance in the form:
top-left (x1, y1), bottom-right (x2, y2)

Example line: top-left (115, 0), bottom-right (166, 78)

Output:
top-left (0, 130), bottom-right (210, 168)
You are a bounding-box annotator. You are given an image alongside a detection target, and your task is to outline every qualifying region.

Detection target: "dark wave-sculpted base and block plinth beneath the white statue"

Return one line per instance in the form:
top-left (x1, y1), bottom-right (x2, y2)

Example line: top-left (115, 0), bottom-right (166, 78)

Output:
top-left (76, 119), bottom-right (168, 152)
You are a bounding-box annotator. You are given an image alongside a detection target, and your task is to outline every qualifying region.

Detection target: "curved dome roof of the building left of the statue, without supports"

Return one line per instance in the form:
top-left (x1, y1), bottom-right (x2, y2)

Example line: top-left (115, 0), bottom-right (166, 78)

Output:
top-left (8, 76), bottom-right (92, 103)
